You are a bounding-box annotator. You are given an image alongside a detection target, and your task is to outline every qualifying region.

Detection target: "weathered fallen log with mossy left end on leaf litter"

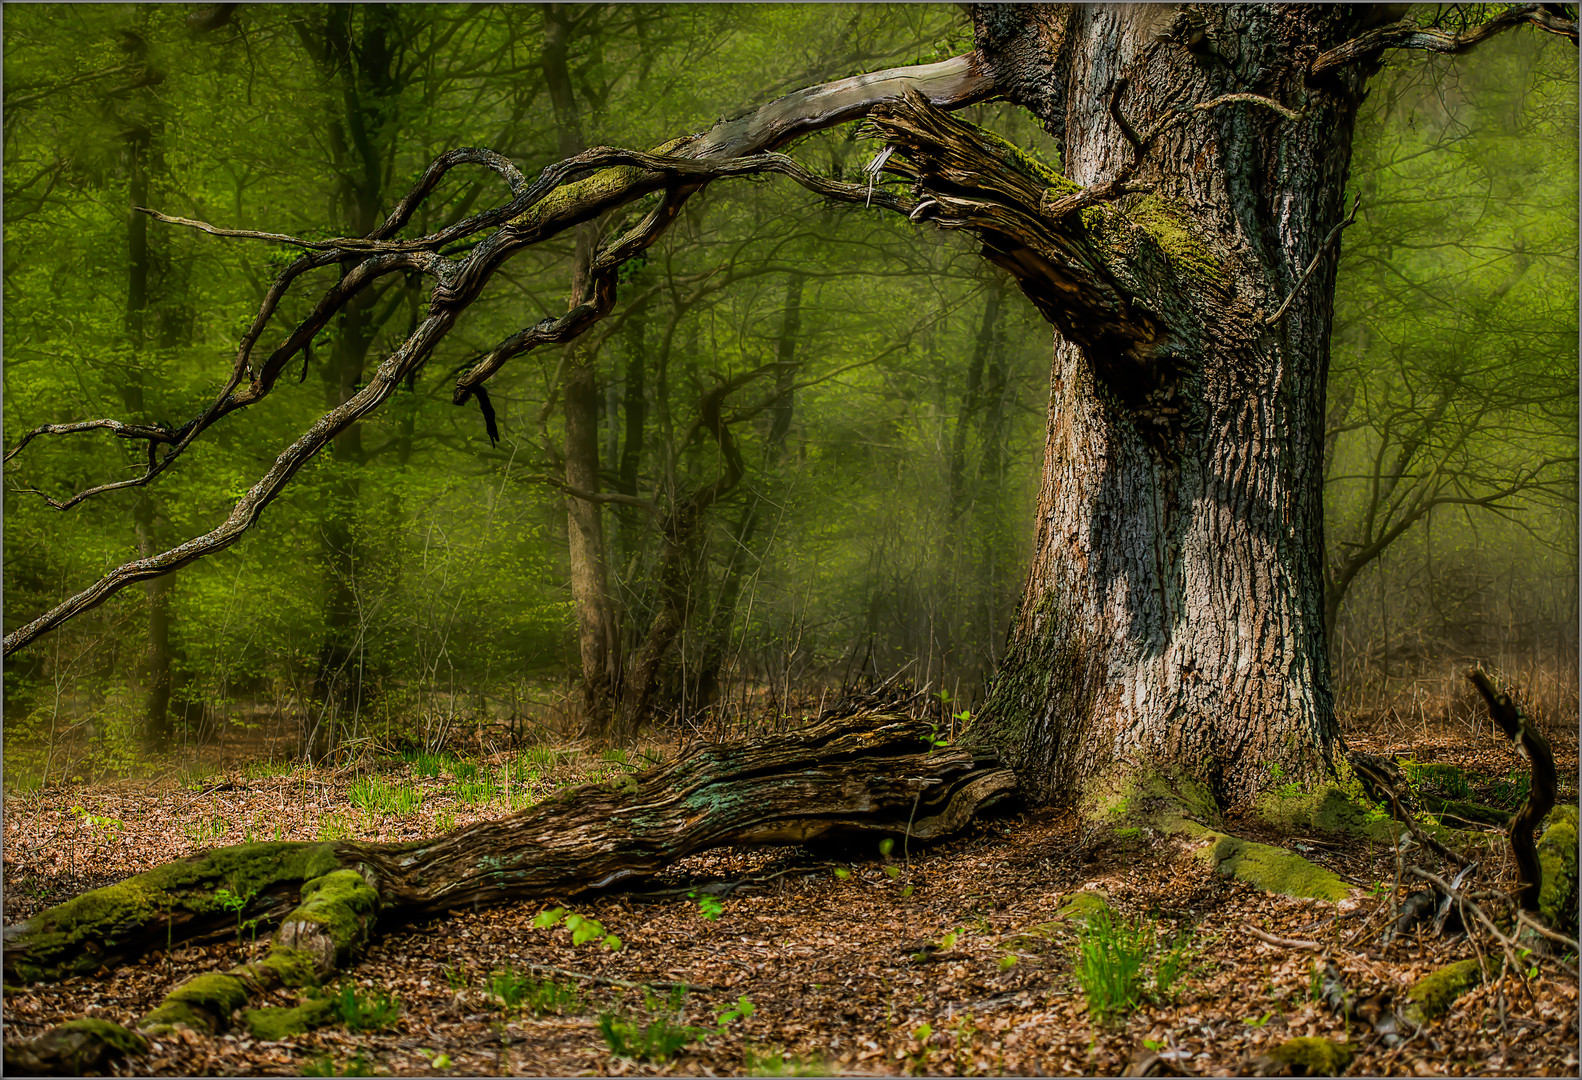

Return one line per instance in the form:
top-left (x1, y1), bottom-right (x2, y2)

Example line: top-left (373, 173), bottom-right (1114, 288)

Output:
top-left (5, 713), bottom-right (1016, 1071)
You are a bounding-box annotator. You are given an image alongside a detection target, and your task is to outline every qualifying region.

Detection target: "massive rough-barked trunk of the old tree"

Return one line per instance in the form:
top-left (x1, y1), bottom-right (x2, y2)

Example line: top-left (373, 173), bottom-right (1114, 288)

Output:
top-left (949, 5), bottom-right (1362, 797)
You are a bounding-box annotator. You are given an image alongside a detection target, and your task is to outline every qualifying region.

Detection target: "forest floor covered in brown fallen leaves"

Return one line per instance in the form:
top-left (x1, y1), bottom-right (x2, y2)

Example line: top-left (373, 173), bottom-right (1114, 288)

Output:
top-left (3, 714), bottom-right (1579, 1075)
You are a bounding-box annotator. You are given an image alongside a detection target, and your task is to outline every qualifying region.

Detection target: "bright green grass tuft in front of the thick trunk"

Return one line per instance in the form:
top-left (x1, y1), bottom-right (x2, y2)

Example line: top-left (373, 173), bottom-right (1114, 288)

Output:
top-left (1074, 911), bottom-right (1190, 1021)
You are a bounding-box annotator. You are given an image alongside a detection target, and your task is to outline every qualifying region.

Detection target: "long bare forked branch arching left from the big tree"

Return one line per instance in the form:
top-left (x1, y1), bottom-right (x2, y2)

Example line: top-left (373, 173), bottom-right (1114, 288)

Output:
top-left (5, 55), bottom-right (995, 656)
